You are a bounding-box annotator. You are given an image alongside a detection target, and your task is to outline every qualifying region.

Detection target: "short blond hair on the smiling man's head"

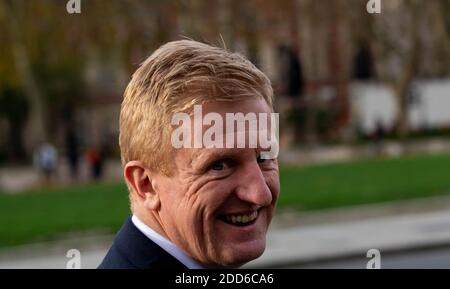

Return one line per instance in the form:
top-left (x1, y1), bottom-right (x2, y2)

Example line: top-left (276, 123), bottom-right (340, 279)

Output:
top-left (119, 40), bottom-right (273, 175)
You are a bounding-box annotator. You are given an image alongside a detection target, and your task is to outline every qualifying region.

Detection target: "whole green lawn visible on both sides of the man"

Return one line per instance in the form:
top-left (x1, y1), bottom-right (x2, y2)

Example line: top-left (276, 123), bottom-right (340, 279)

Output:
top-left (0, 154), bottom-right (450, 246)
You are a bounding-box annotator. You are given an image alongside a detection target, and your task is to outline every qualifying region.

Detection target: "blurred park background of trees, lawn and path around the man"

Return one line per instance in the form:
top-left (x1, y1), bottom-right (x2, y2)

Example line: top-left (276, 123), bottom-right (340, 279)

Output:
top-left (0, 0), bottom-right (450, 268)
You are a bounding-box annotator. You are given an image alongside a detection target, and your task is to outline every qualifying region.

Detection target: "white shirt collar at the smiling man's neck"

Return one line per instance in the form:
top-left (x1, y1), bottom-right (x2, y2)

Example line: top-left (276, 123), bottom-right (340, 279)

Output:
top-left (131, 215), bottom-right (203, 269)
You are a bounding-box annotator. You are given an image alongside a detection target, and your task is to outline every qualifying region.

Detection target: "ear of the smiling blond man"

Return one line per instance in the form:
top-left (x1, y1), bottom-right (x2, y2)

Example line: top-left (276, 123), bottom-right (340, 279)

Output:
top-left (123, 161), bottom-right (161, 210)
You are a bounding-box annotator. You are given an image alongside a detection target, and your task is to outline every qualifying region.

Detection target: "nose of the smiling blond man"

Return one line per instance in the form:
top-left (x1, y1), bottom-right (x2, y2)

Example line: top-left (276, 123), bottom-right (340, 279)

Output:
top-left (236, 161), bottom-right (272, 206)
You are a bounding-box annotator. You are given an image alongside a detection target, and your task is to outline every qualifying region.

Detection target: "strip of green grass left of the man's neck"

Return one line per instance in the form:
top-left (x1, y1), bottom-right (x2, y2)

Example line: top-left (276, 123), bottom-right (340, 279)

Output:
top-left (0, 184), bottom-right (129, 246)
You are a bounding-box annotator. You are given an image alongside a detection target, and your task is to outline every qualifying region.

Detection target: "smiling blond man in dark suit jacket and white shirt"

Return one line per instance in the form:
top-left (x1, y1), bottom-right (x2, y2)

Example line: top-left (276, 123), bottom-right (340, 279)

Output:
top-left (99, 40), bottom-right (280, 269)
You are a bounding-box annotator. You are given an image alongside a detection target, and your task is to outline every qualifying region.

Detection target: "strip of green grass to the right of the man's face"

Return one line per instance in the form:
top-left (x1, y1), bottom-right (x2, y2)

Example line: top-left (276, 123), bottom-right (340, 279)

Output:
top-left (279, 154), bottom-right (450, 210)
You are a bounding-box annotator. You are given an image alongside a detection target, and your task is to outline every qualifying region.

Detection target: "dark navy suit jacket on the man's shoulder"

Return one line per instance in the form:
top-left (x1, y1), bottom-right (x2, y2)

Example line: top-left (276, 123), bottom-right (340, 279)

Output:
top-left (98, 217), bottom-right (187, 269)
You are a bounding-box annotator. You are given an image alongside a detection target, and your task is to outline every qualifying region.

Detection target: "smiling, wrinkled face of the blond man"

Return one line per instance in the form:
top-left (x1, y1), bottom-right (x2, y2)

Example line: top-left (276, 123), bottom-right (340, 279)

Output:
top-left (154, 98), bottom-right (280, 267)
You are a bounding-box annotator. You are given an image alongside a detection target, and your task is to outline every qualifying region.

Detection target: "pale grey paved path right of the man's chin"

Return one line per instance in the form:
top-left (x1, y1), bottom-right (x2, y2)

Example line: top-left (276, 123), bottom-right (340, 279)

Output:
top-left (247, 210), bottom-right (450, 268)
